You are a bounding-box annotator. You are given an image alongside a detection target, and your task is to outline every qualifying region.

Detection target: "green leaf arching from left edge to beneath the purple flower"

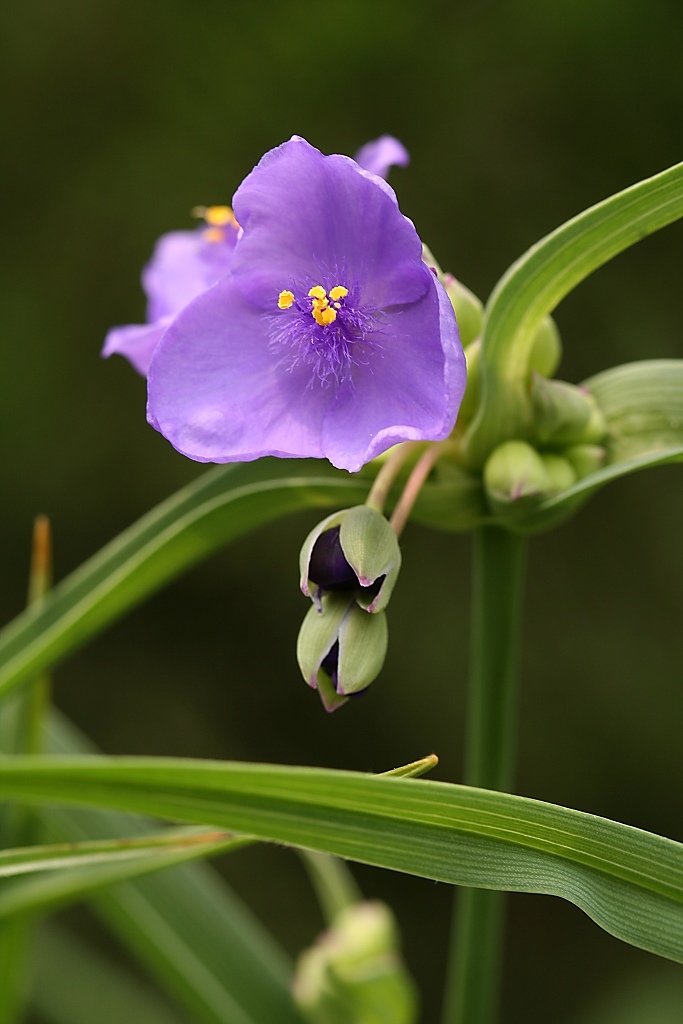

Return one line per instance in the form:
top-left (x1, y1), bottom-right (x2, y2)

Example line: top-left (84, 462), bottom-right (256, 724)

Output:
top-left (0, 463), bottom-right (368, 695)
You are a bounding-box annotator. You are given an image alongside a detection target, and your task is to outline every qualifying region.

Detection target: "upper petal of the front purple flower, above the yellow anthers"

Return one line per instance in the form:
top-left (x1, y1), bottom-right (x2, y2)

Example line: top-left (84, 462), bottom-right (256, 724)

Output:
top-left (231, 138), bottom-right (428, 310)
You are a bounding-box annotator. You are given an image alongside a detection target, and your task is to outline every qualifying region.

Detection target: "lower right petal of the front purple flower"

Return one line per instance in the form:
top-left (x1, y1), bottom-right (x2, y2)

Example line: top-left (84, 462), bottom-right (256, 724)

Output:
top-left (323, 276), bottom-right (467, 472)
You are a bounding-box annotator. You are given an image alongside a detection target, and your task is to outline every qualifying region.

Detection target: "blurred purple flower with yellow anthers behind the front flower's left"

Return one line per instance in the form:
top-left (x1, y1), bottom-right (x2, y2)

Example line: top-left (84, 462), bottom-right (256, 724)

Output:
top-left (102, 206), bottom-right (239, 377)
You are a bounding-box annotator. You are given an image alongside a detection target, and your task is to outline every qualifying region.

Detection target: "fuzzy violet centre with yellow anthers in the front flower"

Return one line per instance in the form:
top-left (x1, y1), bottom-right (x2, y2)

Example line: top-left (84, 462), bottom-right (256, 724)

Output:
top-left (270, 279), bottom-right (380, 384)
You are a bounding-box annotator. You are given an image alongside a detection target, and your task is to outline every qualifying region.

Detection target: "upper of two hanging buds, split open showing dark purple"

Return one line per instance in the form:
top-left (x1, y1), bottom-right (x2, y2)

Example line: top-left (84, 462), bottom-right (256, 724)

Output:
top-left (299, 505), bottom-right (400, 612)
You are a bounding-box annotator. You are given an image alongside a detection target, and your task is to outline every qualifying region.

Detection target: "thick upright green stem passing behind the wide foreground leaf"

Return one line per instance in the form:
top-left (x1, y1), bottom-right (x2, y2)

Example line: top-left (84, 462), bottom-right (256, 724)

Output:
top-left (443, 526), bottom-right (526, 1024)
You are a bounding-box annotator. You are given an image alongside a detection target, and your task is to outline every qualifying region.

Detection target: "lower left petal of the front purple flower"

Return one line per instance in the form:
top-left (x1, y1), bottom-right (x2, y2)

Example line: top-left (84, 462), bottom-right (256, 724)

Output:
top-left (147, 276), bottom-right (335, 462)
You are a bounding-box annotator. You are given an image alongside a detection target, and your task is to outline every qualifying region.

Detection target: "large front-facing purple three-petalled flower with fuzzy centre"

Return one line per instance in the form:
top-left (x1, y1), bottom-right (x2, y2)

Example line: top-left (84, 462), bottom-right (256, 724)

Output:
top-left (147, 137), bottom-right (466, 472)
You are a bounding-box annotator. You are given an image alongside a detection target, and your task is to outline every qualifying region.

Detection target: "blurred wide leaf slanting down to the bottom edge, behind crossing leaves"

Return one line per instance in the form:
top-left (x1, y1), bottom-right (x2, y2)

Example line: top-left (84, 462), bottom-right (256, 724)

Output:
top-left (38, 712), bottom-right (301, 1024)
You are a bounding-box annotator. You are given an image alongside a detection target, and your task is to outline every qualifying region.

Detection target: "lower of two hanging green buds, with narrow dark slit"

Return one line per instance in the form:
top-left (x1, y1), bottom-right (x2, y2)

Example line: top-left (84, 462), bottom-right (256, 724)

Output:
top-left (297, 593), bottom-right (388, 711)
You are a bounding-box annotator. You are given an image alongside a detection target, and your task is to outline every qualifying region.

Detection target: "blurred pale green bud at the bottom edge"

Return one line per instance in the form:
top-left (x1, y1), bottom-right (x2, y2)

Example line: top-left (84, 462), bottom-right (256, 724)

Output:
top-left (294, 901), bottom-right (418, 1024)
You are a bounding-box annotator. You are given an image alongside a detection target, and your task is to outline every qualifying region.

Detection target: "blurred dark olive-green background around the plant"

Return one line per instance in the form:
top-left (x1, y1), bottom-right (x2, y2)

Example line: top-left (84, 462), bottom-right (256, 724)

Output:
top-left (0, 0), bottom-right (683, 1024)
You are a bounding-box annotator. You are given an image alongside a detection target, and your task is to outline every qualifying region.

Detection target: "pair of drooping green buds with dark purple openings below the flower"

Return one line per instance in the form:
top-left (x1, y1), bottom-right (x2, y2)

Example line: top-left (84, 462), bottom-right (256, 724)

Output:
top-left (297, 505), bottom-right (400, 711)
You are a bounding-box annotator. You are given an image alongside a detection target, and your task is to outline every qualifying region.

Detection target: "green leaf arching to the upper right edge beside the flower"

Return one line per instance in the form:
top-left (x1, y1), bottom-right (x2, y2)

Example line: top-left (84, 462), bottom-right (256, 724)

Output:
top-left (466, 157), bottom-right (683, 468)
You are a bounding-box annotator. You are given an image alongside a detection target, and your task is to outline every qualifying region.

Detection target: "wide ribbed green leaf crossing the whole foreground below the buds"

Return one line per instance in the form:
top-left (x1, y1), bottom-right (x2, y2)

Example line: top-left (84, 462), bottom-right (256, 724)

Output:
top-left (0, 757), bottom-right (683, 962)
